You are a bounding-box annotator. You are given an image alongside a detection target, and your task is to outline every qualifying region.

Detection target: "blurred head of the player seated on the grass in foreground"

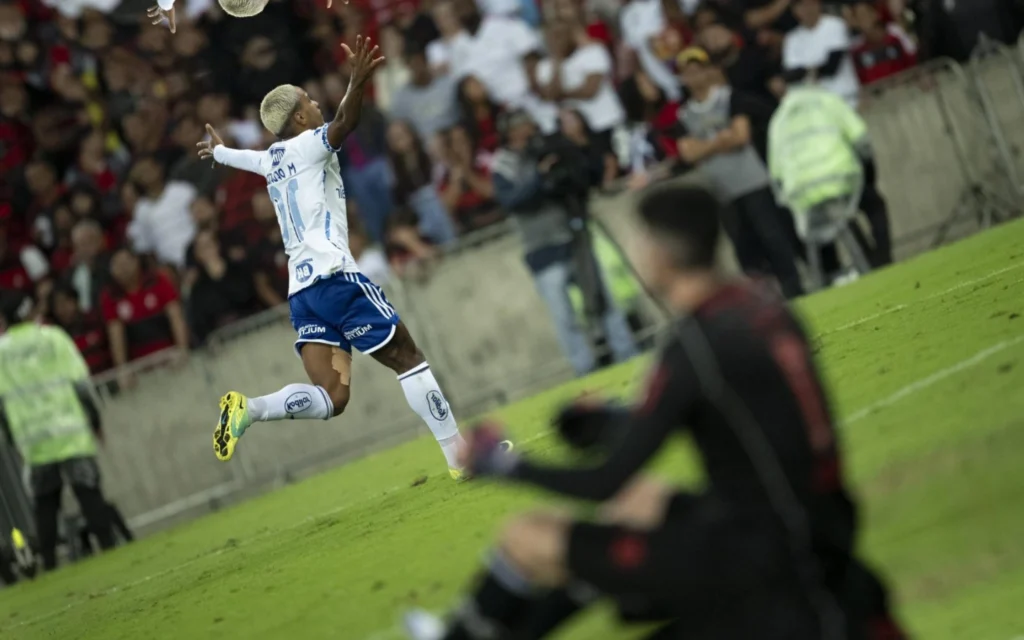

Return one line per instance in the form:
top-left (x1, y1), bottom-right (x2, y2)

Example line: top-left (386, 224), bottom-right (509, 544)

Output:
top-left (632, 185), bottom-right (722, 298)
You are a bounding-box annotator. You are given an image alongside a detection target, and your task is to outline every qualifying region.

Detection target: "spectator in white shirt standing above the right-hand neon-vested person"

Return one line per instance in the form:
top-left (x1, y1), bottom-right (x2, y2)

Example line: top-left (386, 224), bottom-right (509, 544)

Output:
top-left (782, 0), bottom-right (860, 109)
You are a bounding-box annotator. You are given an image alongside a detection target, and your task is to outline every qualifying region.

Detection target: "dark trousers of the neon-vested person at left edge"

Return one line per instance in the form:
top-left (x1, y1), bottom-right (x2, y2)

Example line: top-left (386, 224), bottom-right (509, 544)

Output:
top-left (32, 458), bottom-right (115, 570)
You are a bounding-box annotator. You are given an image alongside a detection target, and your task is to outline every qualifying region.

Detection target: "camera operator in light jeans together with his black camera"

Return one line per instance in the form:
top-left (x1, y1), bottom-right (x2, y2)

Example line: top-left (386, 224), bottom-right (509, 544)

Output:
top-left (492, 112), bottom-right (637, 375)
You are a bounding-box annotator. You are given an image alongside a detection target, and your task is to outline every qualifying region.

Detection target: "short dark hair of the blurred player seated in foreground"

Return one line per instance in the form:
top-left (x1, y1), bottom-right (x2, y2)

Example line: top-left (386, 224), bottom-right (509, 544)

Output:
top-left (639, 185), bottom-right (722, 269)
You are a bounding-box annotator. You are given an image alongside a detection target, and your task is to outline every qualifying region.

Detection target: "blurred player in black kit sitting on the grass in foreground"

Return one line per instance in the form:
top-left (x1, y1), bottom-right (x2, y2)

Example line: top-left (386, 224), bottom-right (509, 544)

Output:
top-left (406, 182), bottom-right (902, 640)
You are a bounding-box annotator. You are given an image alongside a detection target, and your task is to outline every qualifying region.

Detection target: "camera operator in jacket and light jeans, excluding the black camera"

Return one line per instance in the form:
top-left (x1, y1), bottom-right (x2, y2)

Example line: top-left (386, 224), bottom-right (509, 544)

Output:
top-left (495, 112), bottom-right (636, 376)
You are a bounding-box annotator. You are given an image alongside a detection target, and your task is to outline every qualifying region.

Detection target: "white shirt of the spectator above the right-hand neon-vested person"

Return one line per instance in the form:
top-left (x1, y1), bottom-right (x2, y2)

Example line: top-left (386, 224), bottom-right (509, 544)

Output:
top-left (782, 15), bottom-right (860, 109)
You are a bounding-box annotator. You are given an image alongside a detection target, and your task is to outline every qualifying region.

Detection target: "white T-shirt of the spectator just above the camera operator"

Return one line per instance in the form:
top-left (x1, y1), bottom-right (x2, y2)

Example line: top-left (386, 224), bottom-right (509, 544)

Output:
top-left (537, 43), bottom-right (626, 131)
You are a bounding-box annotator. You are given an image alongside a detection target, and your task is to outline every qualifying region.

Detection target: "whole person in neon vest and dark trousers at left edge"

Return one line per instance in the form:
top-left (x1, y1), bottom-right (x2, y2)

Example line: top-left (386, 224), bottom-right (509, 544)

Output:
top-left (0, 294), bottom-right (115, 569)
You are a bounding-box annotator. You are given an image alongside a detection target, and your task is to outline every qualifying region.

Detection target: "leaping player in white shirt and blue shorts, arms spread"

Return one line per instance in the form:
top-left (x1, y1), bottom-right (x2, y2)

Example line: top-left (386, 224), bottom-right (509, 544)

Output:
top-left (198, 37), bottom-right (491, 479)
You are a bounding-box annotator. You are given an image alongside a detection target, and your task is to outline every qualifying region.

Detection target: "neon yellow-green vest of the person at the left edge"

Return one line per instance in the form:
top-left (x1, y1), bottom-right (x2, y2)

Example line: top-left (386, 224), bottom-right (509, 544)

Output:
top-left (0, 323), bottom-right (96, 466)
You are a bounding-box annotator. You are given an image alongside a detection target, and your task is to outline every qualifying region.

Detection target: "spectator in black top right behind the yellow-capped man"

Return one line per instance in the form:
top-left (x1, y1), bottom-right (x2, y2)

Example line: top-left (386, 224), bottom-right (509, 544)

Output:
top-left (699, 23), bottom-right (785, 103)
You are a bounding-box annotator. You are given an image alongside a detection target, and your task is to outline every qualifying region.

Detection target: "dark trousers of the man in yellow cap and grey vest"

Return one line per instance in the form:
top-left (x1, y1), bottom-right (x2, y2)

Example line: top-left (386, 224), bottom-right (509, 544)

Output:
top-left (732, 187), bottom-right (804, 298)
